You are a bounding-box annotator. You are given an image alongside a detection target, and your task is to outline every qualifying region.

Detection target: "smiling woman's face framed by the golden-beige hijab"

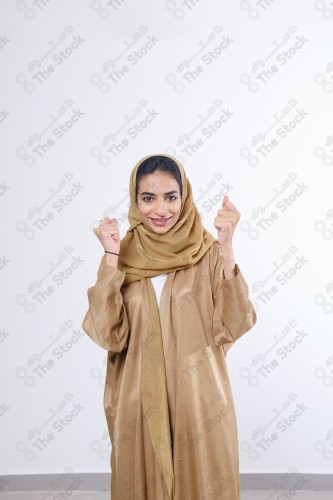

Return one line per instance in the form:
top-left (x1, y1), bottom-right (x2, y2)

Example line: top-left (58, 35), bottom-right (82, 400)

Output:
top-left (137, 170), bottom-right (181, 234)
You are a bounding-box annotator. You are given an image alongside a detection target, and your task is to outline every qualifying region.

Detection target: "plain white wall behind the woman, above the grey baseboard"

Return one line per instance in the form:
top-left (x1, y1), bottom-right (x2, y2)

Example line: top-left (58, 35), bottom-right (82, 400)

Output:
top-left (0, 0), bottom-right (333, 474)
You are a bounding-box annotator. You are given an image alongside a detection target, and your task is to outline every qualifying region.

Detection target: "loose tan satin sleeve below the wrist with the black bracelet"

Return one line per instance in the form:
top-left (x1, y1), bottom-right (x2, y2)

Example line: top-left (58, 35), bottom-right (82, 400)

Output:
top-left (82, 256), bottom-right (130, 355)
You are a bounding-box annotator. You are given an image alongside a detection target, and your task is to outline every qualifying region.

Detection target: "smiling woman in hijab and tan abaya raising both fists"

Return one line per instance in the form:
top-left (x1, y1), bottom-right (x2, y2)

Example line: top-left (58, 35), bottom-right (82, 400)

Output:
top-left (82, 154), bottom-right (256, 500)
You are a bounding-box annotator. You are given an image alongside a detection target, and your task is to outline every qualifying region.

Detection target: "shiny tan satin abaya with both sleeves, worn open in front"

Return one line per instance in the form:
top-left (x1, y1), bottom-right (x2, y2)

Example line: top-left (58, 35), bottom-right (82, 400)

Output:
top-left (82, 240), bottom-right (256, 500)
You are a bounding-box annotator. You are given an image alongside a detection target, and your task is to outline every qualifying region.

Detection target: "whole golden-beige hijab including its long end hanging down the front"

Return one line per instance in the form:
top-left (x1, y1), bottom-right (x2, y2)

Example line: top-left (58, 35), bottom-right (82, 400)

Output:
top-left (118, 154), bottom-right (216, 500)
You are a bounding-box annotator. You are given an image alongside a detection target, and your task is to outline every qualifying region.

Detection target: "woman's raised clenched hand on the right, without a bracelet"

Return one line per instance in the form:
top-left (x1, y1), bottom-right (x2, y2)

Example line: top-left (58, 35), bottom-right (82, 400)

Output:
top-left (214, 196), bottom-right (241, 248)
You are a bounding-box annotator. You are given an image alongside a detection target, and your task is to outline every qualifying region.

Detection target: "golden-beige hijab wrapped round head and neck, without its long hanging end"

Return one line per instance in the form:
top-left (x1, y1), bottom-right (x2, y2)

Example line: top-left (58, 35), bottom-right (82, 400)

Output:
top-left (118, 153), bottom-right (216, 286)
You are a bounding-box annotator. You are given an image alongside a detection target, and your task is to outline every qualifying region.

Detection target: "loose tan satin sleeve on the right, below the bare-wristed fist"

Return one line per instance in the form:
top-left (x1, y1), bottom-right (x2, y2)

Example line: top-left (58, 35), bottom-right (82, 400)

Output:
top-left (210, 242), bottom-right (257, 353)
